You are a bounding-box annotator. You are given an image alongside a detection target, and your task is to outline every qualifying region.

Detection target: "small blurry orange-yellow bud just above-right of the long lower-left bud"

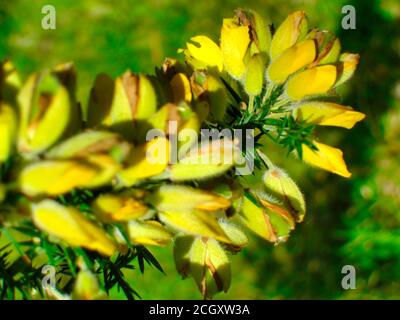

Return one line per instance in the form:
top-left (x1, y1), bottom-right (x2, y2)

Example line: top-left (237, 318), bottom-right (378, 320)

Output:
top-left (91, 194), bottom-right (150, 222)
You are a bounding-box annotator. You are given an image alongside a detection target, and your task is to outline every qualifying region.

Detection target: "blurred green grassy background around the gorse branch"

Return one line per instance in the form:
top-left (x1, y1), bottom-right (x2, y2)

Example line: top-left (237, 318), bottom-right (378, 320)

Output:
top-left (0, 0), bottom-right (400, 299)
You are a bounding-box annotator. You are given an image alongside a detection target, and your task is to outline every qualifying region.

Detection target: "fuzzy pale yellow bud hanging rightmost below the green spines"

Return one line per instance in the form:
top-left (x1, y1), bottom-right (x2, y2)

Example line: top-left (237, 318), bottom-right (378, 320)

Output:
top-left (263, 167), bottom-right (306, 222)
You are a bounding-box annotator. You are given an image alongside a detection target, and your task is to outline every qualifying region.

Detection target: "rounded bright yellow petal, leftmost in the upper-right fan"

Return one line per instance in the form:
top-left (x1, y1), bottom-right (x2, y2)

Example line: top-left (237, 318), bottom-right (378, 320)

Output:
top-left (184, 35), bottom-right (223, 72)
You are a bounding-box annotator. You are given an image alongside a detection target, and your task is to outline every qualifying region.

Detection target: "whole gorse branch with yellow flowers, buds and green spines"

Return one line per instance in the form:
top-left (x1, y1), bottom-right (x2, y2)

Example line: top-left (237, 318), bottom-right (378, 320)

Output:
top-left (0, 9), bottom-right (364, 299)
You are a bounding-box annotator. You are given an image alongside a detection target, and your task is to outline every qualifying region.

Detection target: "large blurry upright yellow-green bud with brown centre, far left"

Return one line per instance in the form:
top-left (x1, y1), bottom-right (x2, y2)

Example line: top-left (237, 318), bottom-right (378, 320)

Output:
top-left (18, 72), bottom-right (73, 155)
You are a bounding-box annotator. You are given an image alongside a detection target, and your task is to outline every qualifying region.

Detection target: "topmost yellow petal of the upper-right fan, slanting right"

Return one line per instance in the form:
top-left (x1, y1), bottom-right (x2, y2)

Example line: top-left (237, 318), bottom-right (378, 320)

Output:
top-left (270, 11), bottom-right (308, 59)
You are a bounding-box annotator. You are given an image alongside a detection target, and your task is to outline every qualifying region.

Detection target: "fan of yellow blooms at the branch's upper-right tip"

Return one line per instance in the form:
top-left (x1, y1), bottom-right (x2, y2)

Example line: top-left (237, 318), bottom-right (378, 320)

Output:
top-left (180, 10), bottom-right (365, 177)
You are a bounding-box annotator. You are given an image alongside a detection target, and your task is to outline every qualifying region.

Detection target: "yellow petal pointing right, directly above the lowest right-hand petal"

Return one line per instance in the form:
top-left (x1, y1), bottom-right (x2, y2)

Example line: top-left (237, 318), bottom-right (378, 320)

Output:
top-left (294, 102), bottom-right (365, 129)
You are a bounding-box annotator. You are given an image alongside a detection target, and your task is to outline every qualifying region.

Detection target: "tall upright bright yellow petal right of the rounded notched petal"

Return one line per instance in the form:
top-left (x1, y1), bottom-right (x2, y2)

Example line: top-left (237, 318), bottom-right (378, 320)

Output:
top-left (221, 19), bottom-right (250, 79)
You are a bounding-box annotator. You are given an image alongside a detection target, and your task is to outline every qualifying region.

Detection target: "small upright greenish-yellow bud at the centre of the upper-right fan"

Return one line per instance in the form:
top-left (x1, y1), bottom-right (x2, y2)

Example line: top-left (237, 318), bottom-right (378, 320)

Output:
top-left (244, 54), bottom-right (264, 96)
